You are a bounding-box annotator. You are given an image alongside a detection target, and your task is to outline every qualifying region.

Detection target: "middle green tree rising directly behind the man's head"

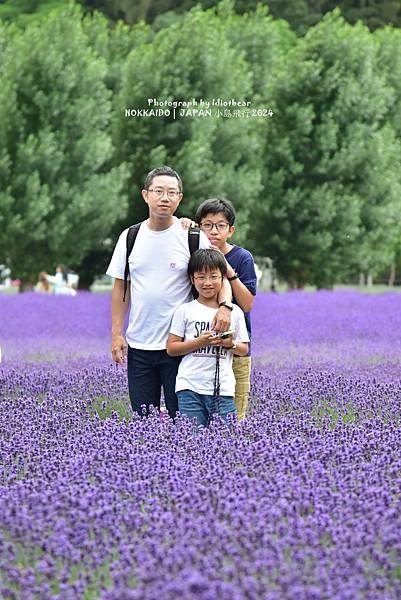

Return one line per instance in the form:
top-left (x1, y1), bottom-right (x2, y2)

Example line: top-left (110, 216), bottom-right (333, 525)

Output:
top-left (115, 4), bottom-right (260, 242)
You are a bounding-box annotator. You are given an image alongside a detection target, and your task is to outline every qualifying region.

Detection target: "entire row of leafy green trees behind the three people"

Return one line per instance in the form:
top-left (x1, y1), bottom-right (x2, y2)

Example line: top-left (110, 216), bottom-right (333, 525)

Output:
top-left (0, 0), bottom-right (401, 287)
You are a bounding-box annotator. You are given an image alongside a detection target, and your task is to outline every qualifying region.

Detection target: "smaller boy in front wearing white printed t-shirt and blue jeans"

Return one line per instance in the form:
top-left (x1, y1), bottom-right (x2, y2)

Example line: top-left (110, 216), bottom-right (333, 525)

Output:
top-left (167, 249), bottom-right (249, 426)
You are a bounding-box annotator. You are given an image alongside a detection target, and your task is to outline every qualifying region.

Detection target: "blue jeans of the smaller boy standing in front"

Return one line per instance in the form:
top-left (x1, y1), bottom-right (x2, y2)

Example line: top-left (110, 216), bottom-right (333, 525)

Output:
top-left (177, 390), bottom-right (236, 427)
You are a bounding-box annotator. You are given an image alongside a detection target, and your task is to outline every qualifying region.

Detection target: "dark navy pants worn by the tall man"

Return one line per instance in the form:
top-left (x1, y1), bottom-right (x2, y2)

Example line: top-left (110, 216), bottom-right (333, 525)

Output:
top-left (128, 347), bottom-right (181, 419)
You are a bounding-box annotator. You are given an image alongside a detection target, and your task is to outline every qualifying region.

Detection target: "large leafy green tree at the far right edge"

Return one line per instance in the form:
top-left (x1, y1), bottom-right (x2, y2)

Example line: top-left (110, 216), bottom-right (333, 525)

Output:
top-left (256, 13), bottom-right (401, 287)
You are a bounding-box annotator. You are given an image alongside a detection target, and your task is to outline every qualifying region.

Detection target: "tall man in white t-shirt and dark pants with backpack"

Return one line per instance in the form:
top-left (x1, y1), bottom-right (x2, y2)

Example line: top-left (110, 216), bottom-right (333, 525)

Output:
top-left (107, 166), bottom-right (232, 418)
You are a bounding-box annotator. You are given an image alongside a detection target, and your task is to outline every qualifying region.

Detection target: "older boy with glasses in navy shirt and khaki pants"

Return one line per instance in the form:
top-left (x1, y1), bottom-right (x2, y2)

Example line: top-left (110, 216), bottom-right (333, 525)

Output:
top-left (195, 198), bottom-right (257, 421)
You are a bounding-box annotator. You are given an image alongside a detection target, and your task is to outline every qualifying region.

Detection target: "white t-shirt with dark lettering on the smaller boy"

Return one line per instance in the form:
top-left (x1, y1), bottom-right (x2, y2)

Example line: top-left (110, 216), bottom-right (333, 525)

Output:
top-left (170, 300), bottom-right (249, 396)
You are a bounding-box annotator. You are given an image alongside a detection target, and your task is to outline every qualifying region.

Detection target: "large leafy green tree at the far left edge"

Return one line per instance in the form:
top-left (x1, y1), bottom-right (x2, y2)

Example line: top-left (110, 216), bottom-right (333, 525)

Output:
top-left (0, 6), bottom-right (126, 288)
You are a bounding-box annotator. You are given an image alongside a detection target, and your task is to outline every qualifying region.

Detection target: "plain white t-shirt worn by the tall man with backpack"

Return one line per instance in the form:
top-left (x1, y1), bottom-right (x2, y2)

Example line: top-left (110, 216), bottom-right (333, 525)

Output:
top-left (106, 217), bottom-right (210, 350)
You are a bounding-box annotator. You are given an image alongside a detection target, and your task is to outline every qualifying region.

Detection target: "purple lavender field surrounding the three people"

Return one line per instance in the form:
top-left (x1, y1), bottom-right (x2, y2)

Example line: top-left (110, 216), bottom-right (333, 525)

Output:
top-left (0, 292), bottom-right (401, 600)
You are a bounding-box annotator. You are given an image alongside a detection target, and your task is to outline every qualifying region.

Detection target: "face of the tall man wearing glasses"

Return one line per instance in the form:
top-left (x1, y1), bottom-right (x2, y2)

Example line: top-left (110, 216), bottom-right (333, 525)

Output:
top-left (142, 175), bottom-right (182, 219)
